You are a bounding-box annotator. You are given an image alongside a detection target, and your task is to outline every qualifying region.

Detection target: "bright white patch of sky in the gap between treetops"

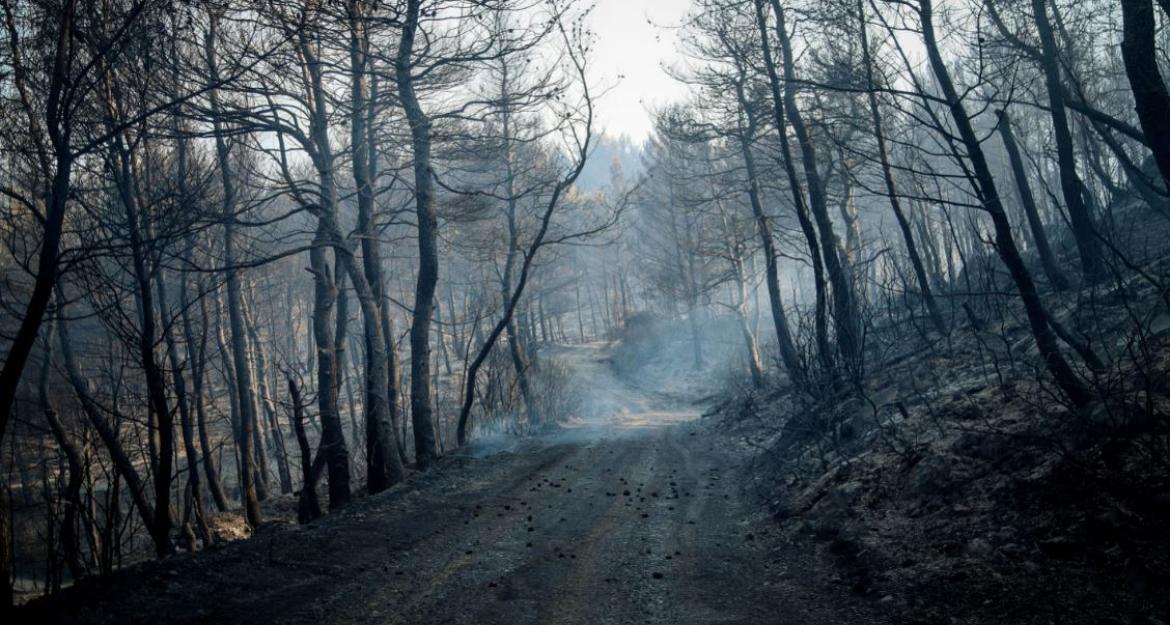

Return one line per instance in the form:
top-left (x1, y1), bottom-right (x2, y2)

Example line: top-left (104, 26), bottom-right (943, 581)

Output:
top-left (590, 0), bottom-right (690, 142)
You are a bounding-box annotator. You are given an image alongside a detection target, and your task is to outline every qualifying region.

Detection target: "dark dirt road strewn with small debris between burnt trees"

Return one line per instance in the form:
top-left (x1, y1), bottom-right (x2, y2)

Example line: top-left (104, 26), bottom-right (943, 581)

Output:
top-left (23, 353), bottom-right (884, 625)
